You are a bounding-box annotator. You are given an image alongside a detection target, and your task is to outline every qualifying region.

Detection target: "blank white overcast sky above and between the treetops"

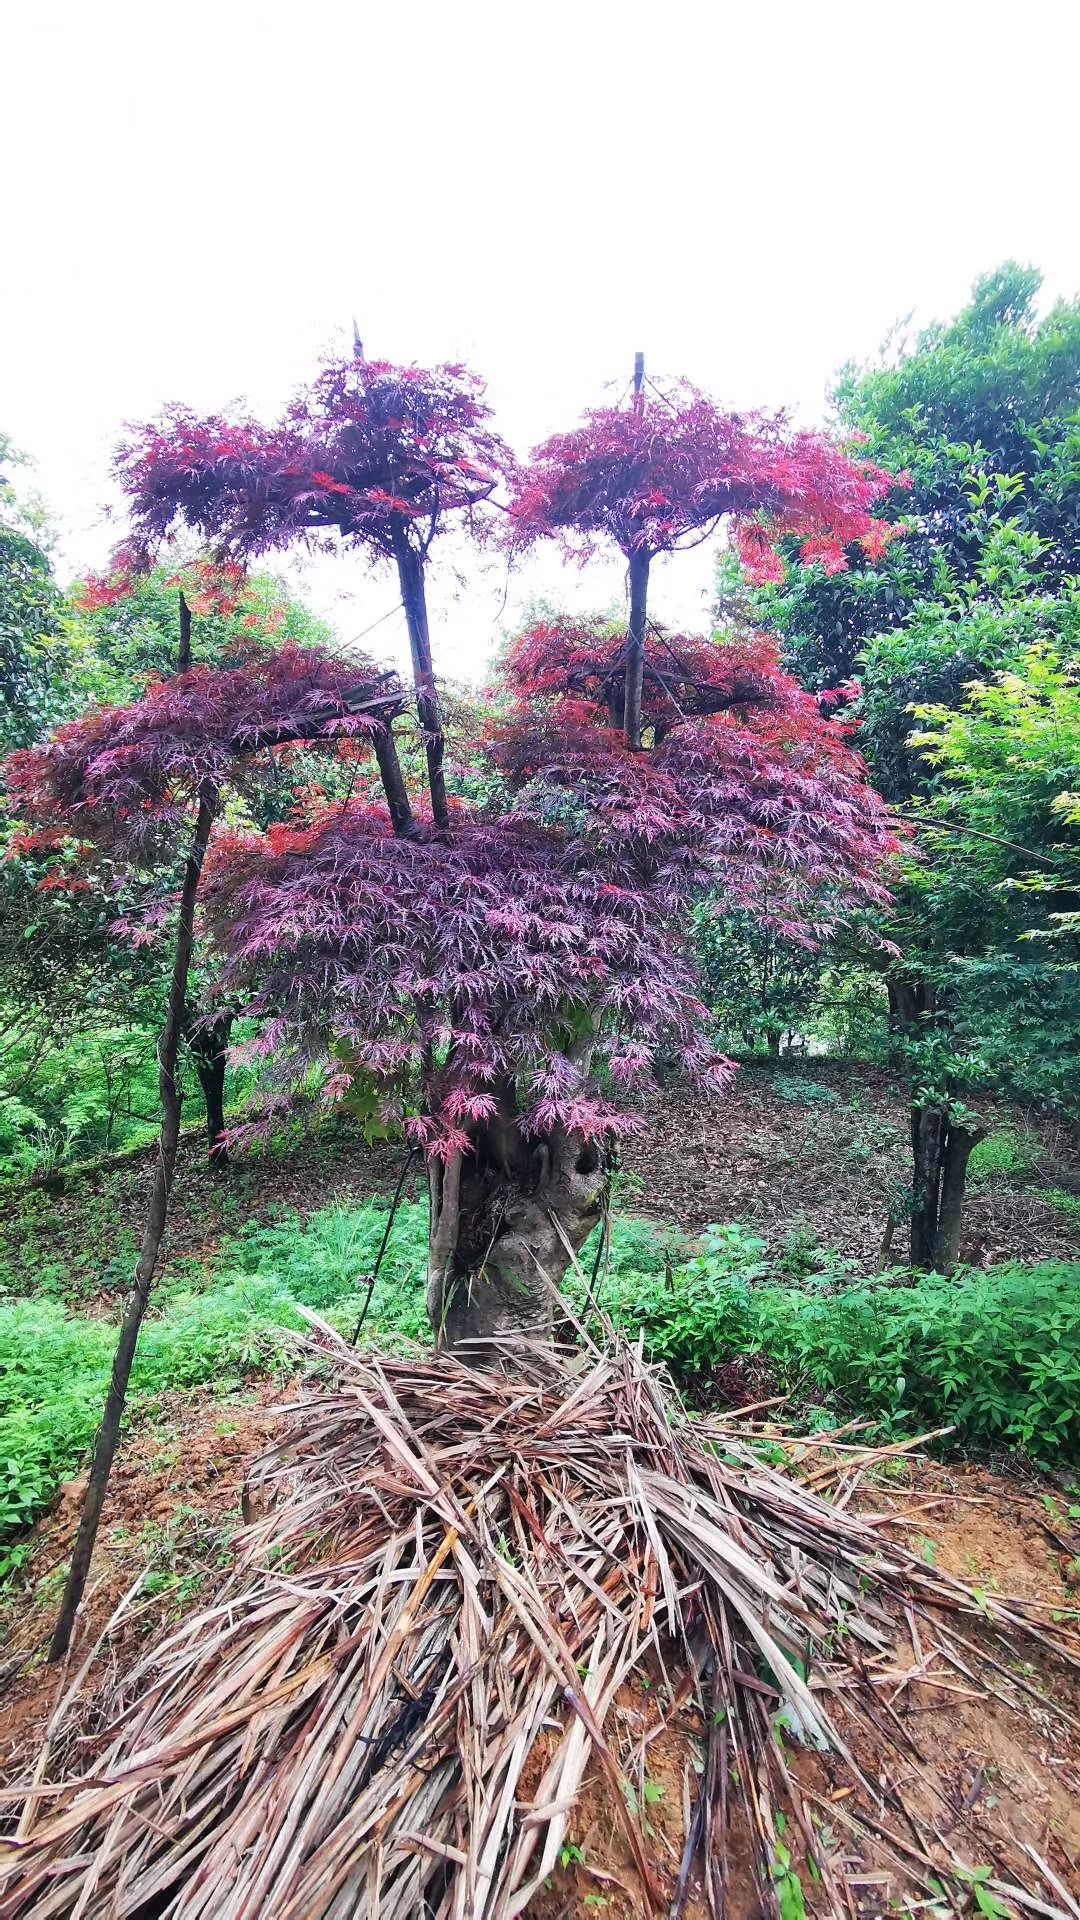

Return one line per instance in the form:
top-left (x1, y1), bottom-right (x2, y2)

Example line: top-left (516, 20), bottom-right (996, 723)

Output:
top-left (0, 0), bottom-right (1080, 670)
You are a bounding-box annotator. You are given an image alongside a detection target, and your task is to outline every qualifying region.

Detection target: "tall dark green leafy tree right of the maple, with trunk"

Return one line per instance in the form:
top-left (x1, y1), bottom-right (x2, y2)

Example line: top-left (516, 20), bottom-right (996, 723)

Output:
top-left (726, 263), bottom-right (1080, 1269)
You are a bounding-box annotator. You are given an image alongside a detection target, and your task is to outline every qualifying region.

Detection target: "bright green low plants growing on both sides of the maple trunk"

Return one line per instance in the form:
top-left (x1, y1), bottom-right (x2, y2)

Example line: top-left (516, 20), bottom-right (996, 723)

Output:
top-left (0, 1198), bottom-right (1080, 1578)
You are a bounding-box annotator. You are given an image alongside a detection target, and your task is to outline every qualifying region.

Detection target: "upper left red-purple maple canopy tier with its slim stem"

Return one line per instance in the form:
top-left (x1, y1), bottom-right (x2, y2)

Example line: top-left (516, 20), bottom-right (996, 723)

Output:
top-left (117, 351), bottom-right (515, 831)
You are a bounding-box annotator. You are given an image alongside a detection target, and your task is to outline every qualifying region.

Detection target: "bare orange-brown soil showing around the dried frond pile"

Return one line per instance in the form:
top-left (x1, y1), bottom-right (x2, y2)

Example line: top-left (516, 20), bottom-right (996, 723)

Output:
top-left (0, 1390), bottom-right (1080, 1920)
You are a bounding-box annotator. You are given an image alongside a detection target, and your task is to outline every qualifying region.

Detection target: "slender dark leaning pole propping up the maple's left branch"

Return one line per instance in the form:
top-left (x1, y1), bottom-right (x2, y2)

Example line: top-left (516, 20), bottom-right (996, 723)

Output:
top-left (48, 787), bottom-right (219, 1661)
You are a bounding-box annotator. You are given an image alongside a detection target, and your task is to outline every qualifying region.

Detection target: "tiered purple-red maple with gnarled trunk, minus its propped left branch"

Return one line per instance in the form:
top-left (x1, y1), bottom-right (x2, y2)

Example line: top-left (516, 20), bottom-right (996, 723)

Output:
top-left (94, 357), bottom-right (890, 1357)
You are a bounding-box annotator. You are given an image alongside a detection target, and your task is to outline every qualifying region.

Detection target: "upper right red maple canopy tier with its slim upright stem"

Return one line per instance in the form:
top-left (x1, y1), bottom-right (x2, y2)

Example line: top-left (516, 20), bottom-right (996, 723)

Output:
top-left (511, 378), bottom-right (905, 749)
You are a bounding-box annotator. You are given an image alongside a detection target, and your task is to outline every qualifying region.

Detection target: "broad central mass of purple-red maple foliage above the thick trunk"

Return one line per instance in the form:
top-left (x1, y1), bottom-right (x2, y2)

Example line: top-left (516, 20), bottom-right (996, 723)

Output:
top-left (208, 622), bottom-right (892, 1160)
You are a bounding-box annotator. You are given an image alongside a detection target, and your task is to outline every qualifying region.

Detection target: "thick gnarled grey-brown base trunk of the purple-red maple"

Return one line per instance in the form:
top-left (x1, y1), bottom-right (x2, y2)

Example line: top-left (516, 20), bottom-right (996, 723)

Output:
top-left (427, 1119), bottom-right (609, 1365)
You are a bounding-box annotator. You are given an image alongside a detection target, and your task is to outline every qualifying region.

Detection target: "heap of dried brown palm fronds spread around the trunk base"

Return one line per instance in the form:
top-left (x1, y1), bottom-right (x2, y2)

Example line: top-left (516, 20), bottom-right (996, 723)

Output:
top-left (0, 1325), bottom-right (1080, 1920)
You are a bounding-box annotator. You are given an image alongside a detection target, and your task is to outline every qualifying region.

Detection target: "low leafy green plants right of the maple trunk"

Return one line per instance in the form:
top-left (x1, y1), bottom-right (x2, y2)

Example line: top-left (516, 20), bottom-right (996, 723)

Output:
top-left (588, 1227), bottom-right (1080, 1461)
